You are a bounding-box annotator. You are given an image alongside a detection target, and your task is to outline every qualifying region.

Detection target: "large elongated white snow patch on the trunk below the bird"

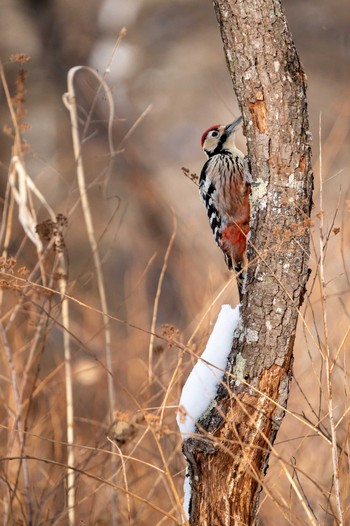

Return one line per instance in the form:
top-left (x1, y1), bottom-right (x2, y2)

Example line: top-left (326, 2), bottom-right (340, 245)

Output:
top-left (176, 305), bottom-right (240, 439)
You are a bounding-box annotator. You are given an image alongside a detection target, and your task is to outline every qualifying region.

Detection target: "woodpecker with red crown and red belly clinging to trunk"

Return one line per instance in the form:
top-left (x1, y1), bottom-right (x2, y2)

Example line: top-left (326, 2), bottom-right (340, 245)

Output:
top-left (199, 117), bottom-right (250, 300)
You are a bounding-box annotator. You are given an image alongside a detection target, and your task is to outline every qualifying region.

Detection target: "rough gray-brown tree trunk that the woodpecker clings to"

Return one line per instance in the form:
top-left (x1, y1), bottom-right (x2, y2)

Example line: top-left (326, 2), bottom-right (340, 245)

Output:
top-left (184, 0), bottom-right (313, 526)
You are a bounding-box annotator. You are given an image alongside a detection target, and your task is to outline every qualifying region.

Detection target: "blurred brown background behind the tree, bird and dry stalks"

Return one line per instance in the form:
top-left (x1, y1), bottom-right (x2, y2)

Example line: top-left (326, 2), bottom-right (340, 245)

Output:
top-left (0, 0), bottom-right (350, 526)
